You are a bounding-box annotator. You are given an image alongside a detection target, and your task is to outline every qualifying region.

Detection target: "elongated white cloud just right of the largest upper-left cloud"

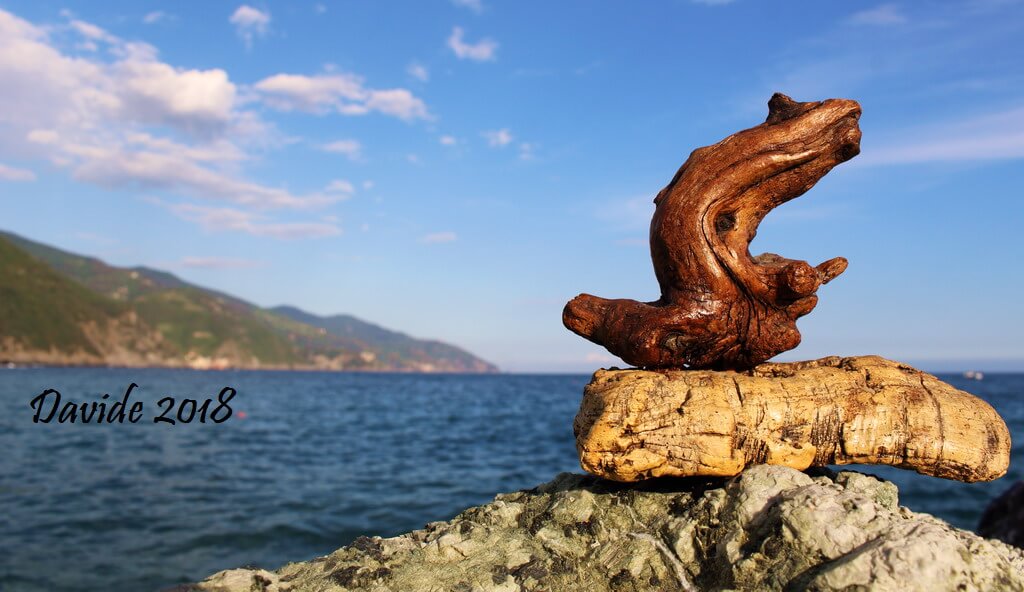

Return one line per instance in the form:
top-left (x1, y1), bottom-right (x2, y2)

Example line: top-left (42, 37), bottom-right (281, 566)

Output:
top-left (255, 73), bottom-right (429, 121)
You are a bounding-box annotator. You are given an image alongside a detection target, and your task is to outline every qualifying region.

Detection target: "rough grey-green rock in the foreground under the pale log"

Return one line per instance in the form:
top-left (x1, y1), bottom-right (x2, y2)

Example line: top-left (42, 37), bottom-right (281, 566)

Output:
top-left (193, 465), bottom-right (1024, 592)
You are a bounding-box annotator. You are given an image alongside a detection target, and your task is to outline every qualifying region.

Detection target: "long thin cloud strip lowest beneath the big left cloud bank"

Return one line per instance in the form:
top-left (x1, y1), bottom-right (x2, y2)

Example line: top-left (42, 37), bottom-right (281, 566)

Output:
top-left (161, 204), bottom-right (341, 240)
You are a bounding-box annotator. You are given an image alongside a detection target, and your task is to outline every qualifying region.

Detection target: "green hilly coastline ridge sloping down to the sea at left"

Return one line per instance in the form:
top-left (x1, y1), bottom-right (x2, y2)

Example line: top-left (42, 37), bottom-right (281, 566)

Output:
top-left (0, 230), bottom-right (498, 372)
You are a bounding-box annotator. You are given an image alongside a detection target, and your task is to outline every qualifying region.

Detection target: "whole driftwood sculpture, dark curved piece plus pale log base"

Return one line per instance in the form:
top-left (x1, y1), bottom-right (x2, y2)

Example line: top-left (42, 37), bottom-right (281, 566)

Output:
top-left (562, 94), bottom-right (1010, 481)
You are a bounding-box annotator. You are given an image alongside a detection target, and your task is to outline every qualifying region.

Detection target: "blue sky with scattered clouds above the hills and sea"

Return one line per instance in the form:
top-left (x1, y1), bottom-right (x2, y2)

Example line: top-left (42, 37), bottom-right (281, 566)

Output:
top-left (0, 0), bottom-right (1024, 372)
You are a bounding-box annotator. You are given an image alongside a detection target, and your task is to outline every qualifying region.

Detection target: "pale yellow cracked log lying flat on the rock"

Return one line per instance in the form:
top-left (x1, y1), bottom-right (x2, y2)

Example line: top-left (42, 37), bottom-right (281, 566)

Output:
top-left (573, 356), bottom-right (1010, 481)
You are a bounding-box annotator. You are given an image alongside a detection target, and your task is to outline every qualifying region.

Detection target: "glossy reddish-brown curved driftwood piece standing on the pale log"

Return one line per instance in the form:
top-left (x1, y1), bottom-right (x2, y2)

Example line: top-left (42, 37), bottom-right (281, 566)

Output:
top-left (562, 94), bottom-right (860, 370)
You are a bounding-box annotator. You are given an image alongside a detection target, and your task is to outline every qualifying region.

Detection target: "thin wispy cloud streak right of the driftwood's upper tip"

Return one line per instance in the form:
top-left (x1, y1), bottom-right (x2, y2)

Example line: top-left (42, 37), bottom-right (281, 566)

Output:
top-left (851, 107), bottom-right (1024, 166)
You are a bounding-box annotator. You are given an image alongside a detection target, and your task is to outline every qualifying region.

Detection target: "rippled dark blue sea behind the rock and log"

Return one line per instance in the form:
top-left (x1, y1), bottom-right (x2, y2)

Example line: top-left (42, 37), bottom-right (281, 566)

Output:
top-left (0, 368), bottom-right (1024, 592)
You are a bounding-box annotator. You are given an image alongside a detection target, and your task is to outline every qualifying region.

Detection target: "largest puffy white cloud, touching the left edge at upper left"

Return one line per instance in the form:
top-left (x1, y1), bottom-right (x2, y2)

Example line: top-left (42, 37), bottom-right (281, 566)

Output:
top-left (0, 11), bottom-right (240, 134)
